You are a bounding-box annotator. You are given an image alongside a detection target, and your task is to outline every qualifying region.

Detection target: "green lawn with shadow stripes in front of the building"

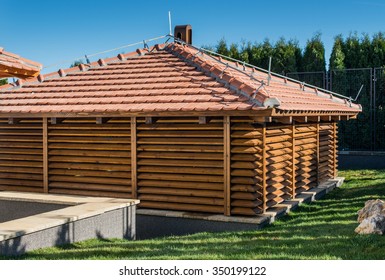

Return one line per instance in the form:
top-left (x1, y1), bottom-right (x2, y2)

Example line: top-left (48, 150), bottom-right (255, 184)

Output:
top-left (3, 170), bottom-right (385, 260)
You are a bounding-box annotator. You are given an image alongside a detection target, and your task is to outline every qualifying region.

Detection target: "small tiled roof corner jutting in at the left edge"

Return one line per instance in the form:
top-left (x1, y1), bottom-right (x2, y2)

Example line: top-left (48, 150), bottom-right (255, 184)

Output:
top-left (0, 47), bottom-right (42, 79)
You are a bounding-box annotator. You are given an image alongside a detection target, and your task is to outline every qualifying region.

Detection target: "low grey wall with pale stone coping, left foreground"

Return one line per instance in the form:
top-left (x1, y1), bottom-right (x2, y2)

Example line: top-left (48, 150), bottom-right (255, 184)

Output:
top-left (0, 192), bottom-right (139, 255)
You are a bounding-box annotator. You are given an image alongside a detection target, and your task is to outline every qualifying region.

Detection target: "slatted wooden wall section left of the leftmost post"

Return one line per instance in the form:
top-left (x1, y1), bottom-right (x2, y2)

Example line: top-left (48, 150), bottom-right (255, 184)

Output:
top-left (0, 119), bottom-right (44, 192)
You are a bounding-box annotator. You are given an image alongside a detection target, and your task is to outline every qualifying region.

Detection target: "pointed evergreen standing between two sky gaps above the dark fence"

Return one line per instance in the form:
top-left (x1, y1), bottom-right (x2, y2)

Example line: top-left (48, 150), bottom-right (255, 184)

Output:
top-left (302, 32), bottom-right (326, 72)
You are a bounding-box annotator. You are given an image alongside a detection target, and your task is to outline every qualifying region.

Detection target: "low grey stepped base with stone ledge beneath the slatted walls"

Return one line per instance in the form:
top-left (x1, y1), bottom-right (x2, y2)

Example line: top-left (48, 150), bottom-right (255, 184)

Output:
top-left (137, 177), bottom-right (344, 239)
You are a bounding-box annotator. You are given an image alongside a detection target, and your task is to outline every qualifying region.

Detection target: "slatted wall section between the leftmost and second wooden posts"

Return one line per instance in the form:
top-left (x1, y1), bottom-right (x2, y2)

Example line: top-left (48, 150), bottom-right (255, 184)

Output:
top-left (48, 118), bottom-right (132, 198)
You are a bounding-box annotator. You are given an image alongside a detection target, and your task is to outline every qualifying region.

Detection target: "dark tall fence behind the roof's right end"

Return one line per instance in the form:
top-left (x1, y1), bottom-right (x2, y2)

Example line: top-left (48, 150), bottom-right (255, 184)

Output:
top-left (287, 68), bottom-right (385, 151)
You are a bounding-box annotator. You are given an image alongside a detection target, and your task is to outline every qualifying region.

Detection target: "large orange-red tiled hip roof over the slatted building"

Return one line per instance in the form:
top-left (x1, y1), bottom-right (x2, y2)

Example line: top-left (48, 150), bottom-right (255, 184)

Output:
top-left (0, 43), bottom-right (361, 116)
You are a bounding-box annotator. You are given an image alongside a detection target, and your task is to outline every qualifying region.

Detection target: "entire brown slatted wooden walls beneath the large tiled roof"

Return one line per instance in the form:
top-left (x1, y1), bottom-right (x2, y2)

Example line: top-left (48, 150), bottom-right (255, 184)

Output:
top-left (0, 117), bottom-right (337, 216)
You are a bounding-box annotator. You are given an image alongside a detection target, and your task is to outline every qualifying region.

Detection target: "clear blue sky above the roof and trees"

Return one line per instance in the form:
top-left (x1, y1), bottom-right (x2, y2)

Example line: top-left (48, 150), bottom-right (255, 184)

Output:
top-left (0, 0), bottom-right (385, 73)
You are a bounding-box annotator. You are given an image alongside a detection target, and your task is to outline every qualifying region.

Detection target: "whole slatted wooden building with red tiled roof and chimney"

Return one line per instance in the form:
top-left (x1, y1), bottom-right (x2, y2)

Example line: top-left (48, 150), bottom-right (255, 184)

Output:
top-left (0, 26), bottom-right (361, 216)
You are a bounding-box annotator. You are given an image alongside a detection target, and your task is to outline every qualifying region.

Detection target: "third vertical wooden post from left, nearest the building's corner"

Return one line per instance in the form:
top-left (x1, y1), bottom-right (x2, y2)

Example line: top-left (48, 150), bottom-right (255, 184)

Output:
top-left (223, 116), bottom-right (231, 216)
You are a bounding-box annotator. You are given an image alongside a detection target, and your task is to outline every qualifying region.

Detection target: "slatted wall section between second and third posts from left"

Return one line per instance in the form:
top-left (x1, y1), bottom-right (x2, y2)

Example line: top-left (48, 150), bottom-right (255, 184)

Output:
top-left (137, 117), bottom-right (225, 214)
